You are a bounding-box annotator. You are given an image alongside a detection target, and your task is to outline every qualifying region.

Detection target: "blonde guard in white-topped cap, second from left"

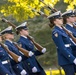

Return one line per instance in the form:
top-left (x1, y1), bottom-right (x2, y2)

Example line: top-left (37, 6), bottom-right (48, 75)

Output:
top-left (1, 26), bottom-right (28, 75)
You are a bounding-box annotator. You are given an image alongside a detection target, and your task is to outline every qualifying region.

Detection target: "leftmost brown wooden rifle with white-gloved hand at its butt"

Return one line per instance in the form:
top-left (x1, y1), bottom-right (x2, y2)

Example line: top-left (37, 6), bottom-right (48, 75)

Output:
top-left (0, 42), bottom-right (22, 63)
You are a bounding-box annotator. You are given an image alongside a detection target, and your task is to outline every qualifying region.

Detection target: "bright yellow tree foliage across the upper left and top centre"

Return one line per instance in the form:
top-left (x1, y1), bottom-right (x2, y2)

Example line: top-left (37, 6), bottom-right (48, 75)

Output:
top-left (0, 0), bottom-right (59, 21)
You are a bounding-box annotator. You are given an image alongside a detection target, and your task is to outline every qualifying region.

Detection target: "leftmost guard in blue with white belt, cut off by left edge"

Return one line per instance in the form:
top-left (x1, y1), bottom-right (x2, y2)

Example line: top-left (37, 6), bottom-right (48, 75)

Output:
top-left (0, 34), bottom-right (16, 75)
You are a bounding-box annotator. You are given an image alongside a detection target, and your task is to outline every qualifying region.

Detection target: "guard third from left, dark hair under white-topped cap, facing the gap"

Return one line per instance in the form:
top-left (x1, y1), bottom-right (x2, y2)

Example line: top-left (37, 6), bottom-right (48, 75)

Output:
top-left (16, 22), bottom-right (46, 75)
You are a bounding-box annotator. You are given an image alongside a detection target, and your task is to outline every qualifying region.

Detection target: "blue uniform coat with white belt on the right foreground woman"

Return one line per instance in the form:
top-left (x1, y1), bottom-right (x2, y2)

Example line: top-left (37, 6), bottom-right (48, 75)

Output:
top-left (52, 26), bottom-right (75, 75)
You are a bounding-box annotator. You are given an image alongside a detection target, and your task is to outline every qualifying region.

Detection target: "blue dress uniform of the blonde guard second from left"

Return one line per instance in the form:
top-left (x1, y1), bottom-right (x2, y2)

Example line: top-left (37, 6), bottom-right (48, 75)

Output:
top-left (5, 40), bottom-right (28, 75)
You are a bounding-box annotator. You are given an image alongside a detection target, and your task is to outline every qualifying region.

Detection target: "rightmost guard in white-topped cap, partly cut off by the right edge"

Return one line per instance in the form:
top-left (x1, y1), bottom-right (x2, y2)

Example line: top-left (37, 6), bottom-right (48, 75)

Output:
top-left (62, 10), bottom-right (76, 72)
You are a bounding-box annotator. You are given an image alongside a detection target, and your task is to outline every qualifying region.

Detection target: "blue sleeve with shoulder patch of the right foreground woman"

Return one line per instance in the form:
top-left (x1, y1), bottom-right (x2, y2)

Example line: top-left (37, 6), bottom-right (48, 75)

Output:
top-left (52, 32), bottom-right (75, 62)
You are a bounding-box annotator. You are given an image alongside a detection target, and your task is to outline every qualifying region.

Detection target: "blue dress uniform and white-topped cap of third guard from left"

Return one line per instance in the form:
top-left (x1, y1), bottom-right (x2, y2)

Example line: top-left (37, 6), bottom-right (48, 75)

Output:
top-left (16, 22), bottom-right (46, 75)
